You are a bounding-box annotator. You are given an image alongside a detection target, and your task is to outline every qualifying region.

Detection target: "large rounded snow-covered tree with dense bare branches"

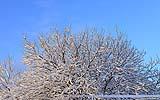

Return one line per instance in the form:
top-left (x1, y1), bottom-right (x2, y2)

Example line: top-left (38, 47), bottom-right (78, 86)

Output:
top-left (0, 28), bottom-right (160, 100)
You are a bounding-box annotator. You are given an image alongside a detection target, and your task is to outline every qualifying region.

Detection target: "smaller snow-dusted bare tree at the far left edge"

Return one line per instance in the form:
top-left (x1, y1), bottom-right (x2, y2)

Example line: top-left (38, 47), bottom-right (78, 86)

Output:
top-left (0, 58), bottom-right (15, 100)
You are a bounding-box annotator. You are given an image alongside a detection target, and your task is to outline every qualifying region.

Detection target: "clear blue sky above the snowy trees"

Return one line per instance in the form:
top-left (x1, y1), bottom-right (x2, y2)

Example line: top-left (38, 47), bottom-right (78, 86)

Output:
top-left (0, 0), bottom-right (160, 70)
